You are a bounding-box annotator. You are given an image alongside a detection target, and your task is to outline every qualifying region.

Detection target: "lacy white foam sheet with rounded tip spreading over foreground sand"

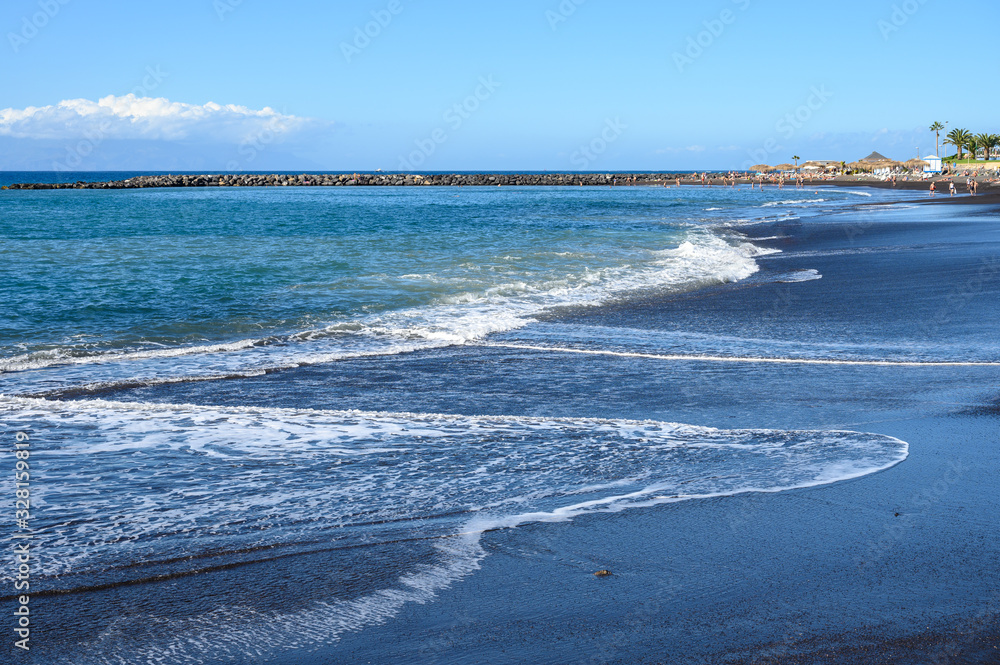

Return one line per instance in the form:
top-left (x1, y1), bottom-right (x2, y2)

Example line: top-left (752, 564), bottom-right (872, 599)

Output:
top-left (0, 398), bottom-right (908, 664)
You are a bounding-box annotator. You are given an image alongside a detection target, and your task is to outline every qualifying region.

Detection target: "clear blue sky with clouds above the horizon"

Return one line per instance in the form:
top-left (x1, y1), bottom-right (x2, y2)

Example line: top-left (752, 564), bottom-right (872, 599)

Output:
top-left (0, 0), bottom-right (1000, 171)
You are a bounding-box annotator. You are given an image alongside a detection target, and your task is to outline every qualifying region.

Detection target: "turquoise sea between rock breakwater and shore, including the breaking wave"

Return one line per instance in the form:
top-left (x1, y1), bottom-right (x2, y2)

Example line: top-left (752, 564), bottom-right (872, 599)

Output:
top-left (0, 182), bottom-right (788, 387)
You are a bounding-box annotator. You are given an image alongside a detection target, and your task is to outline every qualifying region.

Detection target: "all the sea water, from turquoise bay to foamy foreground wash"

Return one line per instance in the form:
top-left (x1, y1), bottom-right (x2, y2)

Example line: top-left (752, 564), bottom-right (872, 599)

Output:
top-left (0, 176), bottom-right (916, 663)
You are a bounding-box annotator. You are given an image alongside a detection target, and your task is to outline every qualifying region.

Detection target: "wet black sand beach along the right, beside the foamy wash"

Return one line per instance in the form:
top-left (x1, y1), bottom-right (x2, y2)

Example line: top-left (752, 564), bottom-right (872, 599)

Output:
top-left (88, 191), bottom-right (1000, 664)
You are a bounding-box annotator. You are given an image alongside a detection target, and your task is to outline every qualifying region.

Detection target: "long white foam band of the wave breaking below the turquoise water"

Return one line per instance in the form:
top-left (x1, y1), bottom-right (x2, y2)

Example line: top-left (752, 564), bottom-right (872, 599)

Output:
top-left (0, 229), bottom-right (764, 394)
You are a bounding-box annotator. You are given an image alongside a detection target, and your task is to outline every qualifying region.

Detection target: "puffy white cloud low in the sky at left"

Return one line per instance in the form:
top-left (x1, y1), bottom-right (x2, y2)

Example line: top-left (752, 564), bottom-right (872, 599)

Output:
top-left (0, 94), bottom-right (311, 143)
